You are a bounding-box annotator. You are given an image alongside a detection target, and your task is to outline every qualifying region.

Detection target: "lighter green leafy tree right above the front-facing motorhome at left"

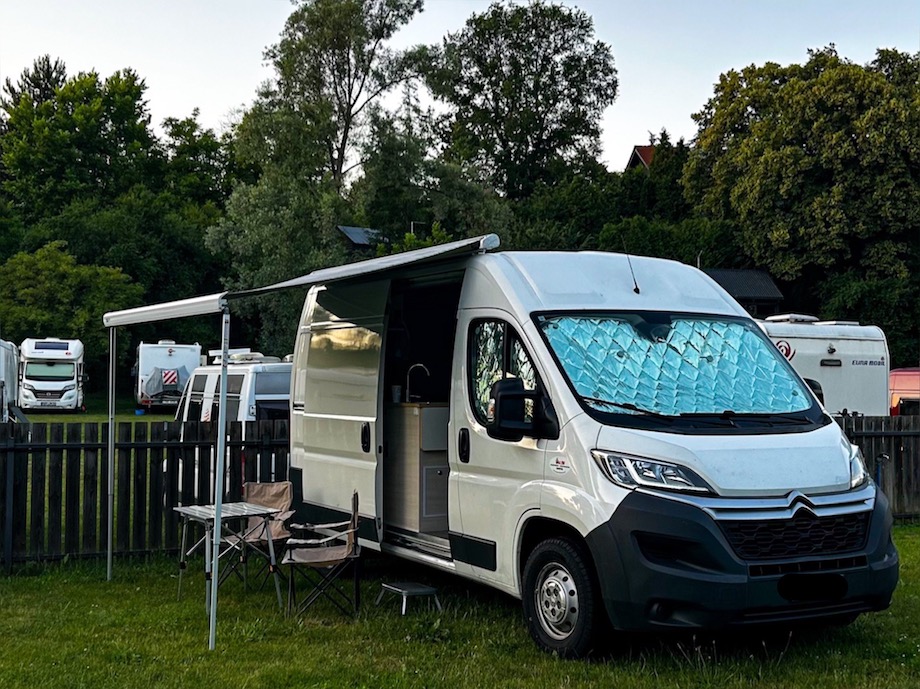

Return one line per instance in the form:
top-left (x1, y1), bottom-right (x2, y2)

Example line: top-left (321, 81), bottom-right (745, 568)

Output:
top-left (0, 242), bottom-right (143, 371)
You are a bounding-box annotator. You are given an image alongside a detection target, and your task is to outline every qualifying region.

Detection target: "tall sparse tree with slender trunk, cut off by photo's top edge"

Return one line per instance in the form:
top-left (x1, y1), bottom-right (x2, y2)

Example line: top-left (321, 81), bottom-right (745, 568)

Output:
top-left (261, 0), bottom-right (424, 192)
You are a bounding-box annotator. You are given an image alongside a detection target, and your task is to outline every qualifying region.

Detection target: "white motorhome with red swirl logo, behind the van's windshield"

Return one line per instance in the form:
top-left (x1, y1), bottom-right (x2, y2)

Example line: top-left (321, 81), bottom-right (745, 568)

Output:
top-left (758, 313), bottom-right (891, 416)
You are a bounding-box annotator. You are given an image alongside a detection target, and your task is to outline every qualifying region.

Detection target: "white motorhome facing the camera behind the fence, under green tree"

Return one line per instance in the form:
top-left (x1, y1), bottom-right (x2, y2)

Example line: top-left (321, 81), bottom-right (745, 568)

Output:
top-left (19, 337), bottom-right (86, 411)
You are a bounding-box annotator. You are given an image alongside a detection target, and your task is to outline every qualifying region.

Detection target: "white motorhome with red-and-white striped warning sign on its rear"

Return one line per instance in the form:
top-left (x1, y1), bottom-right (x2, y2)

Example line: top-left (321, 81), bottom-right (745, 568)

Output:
top-left (132, 340), bottom-right (201, 409)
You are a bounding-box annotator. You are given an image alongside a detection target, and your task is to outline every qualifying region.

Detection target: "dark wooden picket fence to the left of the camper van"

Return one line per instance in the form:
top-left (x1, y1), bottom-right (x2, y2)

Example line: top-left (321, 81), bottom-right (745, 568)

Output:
top-left (0, 421), bottom-right (289, 572)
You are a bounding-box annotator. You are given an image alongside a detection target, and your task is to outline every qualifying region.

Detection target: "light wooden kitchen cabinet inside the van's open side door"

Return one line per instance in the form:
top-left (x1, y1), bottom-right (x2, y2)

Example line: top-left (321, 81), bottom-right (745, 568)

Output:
top-left (383, 404), bottom-right (448, 533)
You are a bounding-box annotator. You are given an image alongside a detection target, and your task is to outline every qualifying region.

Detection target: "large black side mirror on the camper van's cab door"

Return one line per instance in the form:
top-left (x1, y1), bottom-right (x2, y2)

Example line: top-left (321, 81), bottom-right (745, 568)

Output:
top-left (486, 378), bottom-right (559, 442)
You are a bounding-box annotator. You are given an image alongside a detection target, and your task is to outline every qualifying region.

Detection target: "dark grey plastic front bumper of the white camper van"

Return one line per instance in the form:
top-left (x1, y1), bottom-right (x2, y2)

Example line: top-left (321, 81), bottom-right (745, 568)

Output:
top-left (587, 484), bottom-right (898, 630)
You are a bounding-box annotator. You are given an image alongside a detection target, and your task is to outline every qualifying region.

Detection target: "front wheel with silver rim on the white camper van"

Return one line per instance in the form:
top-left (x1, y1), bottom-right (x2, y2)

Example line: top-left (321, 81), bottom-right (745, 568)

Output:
top-left (523, 538), bottom-right (599, 658)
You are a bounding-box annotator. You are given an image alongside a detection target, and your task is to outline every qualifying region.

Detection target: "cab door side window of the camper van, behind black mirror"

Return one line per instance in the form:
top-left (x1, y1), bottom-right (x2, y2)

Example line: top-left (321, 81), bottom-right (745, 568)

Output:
top-left (468, 321), bottom-right (537, 425)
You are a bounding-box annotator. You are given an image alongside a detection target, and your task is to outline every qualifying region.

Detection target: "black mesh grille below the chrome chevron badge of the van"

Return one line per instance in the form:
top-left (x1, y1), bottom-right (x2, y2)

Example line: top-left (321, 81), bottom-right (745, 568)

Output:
top-left (719, 510), bottom-right (870, 560)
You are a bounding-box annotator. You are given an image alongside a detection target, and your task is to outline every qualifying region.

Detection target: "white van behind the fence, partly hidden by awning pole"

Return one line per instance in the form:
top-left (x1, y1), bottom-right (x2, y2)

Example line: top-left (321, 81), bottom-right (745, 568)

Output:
top-left (176, 350), bottom-right (292, 421)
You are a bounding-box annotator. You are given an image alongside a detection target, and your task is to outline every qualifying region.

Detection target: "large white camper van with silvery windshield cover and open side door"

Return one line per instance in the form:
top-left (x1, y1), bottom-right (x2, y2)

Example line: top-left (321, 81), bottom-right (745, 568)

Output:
top-left (290, 235), bottom-right (898, 657)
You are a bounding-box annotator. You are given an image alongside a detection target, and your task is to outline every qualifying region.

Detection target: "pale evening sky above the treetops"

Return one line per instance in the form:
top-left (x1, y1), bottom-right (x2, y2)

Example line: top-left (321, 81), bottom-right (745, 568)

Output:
top-left (0, 0), bottom-right (920, 170)
